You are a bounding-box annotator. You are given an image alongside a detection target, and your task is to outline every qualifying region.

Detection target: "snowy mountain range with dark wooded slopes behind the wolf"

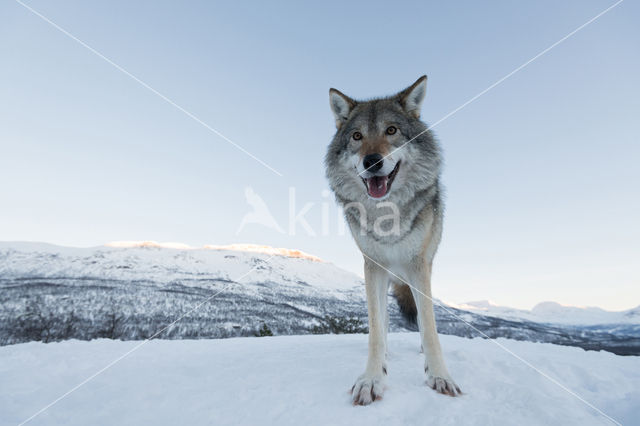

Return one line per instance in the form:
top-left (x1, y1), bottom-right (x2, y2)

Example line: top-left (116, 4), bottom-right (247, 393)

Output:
top-left (0, 242), bottom-right (640, 355)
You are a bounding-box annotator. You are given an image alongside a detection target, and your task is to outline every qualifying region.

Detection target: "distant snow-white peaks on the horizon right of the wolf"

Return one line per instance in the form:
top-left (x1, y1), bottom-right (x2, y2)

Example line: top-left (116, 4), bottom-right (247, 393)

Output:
top-left (450, 300), bottom-right (640, 326)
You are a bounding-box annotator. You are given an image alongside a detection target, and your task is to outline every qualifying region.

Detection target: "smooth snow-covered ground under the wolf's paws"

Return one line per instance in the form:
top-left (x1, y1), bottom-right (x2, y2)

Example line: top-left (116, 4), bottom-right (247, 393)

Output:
top-left (0, 333), bottom-right (640, 426)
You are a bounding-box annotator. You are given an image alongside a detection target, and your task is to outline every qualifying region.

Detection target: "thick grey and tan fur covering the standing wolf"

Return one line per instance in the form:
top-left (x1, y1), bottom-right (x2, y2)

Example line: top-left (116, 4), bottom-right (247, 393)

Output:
top-left (325, 76), bottom-right (460, 404)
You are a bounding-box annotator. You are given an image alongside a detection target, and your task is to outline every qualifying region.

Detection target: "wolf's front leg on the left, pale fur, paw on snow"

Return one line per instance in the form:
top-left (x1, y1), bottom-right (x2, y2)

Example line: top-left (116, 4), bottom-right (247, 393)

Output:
top-left (351, 259), bottom-right (389, 405)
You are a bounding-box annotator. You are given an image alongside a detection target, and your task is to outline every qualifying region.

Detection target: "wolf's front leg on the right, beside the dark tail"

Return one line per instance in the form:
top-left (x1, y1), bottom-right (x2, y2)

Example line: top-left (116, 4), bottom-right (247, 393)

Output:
top-left (409, 261), bottom-right (462, 396)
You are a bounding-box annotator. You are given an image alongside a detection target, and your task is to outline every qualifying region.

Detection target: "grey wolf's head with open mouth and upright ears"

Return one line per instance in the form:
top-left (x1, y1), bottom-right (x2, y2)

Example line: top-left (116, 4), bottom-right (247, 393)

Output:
top-left (325, 76), bottom-right (440, 208)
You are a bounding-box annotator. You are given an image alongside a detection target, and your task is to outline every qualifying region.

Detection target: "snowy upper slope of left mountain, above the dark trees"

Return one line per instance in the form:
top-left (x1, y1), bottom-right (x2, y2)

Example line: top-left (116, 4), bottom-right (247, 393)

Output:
top-left (0, 242), bottom-right (362, 291)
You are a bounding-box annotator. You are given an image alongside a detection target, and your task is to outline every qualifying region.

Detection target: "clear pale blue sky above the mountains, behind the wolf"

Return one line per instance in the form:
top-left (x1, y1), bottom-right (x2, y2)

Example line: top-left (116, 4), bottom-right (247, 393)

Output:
top-left (0, 0), bottom-right (640, 309)
